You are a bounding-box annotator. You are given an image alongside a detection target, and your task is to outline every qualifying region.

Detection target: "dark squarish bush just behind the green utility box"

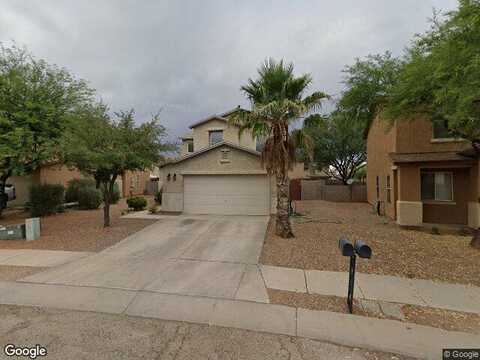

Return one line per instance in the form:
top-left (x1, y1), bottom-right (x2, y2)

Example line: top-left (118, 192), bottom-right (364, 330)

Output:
top-left (29, 184), bottom-right (65, 217)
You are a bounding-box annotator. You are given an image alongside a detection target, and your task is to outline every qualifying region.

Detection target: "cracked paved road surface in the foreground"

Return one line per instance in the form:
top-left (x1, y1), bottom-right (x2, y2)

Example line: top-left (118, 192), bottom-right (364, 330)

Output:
top-left (0, 305), bottom-right (407, 360)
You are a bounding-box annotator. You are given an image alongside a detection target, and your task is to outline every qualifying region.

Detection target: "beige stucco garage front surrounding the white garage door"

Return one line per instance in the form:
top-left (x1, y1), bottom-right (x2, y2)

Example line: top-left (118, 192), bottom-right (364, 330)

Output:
top-left (161, 145), bottom-right (276, 213)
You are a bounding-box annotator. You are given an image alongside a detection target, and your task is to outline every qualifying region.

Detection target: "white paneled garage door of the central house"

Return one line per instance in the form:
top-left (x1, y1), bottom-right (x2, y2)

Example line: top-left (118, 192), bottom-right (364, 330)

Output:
top-left (183, 175), bottom-right (270, 215)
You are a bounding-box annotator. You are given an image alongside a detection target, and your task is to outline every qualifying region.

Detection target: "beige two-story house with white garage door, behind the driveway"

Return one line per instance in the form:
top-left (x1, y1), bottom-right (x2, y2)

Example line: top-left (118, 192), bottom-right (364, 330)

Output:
top-left (161, 108), bottom-right (276, 215)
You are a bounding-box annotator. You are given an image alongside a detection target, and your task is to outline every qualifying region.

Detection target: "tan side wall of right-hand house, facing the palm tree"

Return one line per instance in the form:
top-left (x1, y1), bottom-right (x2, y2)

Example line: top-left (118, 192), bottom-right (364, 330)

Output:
top-left (367, 117), bottom-right (396, 218)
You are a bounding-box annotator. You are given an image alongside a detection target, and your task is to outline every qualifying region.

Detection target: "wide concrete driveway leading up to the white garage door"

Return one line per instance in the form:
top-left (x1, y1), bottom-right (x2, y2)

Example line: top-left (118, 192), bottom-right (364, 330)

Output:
top-left (21, 215), bottom-right (268, 302)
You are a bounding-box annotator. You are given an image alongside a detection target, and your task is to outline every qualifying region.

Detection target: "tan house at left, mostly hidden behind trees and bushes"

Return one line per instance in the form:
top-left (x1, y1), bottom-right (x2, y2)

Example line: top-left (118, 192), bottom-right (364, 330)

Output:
top-left (7, 164), bottom-right (150, 207)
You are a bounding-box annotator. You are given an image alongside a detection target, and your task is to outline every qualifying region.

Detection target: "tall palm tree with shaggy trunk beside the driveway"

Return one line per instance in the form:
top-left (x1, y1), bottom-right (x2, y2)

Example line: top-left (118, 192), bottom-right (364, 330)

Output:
top-left (231, 59), bottom-right (328, 238)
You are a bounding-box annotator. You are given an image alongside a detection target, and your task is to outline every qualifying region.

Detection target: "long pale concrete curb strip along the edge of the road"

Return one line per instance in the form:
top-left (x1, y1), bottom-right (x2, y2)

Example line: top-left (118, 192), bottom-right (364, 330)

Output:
top-left (0, 282), bottom-right (480, 359)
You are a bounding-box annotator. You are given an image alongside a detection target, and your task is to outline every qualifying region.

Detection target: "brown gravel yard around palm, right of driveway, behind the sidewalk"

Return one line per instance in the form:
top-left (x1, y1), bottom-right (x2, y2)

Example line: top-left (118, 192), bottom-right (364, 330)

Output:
top-left (260, 201), bottom-right (480, 286)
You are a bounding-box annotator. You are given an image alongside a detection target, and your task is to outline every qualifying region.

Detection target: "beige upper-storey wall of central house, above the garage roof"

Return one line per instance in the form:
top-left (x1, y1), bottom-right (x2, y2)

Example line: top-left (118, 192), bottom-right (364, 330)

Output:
top-left (193, 119), bottom-right (256, 152)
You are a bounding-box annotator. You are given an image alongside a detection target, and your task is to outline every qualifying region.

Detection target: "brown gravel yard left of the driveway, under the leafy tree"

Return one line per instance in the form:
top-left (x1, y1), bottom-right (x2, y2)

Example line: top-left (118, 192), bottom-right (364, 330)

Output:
top-left (0, 196), bottom-right (155, 251)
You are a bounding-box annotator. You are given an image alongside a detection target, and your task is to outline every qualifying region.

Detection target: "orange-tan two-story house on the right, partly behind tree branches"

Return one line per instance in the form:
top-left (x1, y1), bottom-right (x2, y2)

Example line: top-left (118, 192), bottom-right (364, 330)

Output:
top-left (367, 117), bottom-right (480, 227)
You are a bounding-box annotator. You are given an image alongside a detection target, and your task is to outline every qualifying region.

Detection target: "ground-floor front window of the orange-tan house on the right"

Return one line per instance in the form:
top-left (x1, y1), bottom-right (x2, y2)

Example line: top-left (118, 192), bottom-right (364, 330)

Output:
top-left (421, 171), bottom-right (453, 201)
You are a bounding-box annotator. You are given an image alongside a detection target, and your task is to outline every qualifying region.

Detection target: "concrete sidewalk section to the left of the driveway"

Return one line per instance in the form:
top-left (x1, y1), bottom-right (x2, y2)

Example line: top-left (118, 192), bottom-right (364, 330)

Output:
top-left (0, 249), bottom-right (92, 267)
